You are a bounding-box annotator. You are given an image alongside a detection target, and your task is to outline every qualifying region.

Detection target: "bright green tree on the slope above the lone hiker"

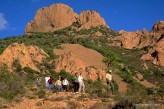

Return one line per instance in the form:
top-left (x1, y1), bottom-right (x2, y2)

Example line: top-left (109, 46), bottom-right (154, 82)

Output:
top-left (102, 50), bottom-right (117, 68)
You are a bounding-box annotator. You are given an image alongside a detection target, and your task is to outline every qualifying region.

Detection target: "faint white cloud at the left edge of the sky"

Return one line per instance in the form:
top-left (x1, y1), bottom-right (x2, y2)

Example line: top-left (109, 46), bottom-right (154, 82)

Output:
top-left (0, 13), bottom-right (8, 30)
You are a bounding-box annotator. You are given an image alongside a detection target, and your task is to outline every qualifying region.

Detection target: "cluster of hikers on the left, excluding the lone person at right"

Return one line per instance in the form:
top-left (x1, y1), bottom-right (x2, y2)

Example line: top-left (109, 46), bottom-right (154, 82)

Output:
top-left (36, 73), bottom-right (85, 93)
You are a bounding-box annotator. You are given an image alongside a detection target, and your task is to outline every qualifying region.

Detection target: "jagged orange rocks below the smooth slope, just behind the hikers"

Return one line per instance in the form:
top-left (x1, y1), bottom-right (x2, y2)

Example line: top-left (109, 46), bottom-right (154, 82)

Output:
top-left (55, 52), bottom-right (106, 80)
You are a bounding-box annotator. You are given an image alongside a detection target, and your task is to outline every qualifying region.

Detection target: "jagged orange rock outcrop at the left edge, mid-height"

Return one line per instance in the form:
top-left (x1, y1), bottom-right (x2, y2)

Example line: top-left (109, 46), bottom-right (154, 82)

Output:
top-left (0, 43), bottom-right (48, 71)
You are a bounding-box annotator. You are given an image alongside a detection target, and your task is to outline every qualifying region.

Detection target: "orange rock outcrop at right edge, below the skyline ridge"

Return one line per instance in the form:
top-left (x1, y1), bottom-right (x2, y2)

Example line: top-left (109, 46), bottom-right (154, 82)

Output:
top-left (141, 34), bottom-right (164, 66)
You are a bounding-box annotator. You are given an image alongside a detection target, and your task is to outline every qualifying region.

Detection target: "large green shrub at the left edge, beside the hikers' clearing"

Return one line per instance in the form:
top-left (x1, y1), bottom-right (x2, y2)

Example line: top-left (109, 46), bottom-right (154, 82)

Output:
top-left (0, 67), bottom-right (25, 100)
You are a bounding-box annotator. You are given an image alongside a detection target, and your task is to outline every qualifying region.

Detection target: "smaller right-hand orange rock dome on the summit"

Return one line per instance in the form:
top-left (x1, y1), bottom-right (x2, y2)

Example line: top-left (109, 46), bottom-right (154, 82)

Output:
top-left (78, 11), bottom-right (107, 29)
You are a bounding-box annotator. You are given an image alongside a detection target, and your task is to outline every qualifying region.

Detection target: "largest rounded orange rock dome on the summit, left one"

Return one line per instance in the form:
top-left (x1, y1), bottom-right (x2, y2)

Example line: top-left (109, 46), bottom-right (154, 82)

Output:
top-left (25, 4), bottom-right (77, 33)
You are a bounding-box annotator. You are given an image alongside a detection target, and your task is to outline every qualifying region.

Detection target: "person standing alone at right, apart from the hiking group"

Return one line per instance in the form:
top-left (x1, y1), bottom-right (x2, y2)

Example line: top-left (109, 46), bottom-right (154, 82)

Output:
top-left (106, 70), bottom-right (114, 94)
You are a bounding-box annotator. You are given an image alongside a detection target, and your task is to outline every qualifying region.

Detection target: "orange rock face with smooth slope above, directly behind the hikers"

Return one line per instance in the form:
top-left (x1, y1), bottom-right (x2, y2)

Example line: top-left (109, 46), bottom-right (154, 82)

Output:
top-left (54, 44), bottom-right (106, 80)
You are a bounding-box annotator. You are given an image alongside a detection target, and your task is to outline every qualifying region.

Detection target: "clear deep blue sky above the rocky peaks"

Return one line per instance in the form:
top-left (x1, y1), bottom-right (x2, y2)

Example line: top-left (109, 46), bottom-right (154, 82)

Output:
top-left (0, 0), bottom-right (164, 38)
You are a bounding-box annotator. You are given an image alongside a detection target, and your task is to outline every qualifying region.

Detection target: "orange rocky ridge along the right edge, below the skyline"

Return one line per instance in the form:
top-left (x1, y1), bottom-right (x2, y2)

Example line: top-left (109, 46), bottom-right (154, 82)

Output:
top-left (114, 21), bottom-right (164, 66)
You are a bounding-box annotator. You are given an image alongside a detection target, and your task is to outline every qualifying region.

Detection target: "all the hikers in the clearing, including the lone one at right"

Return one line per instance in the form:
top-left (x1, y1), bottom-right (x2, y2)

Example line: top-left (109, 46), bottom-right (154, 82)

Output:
top-left (36, 70), bottom-right (114, 93)
